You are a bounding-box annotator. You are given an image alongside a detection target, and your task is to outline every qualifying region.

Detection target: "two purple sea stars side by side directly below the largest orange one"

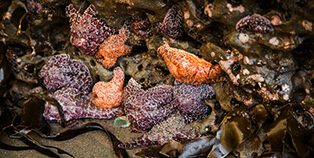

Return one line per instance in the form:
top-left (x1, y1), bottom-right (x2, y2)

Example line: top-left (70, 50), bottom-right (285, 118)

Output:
top-left (123, 78), bottom-right (214, 132)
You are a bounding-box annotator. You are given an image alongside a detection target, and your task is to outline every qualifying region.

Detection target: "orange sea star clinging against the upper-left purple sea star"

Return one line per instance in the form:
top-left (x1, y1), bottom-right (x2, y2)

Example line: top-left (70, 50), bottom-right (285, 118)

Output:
top-left (96, 27), bottom-right (131, 68)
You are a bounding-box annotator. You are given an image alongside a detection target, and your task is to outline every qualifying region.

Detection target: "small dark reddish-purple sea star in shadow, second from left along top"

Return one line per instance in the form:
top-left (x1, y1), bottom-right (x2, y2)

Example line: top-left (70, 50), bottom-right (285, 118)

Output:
top-left (130, 17), bottom-right (152, 38)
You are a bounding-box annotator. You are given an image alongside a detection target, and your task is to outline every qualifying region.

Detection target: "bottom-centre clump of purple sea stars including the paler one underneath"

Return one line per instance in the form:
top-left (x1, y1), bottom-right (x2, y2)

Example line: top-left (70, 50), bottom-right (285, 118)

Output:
top-left (120, 78), bottom-right (214, 149)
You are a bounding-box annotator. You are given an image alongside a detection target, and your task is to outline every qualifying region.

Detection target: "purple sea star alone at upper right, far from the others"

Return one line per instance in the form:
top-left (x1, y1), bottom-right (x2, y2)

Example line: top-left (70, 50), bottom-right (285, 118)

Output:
top-left (236, 14), bottom-right (274, 34)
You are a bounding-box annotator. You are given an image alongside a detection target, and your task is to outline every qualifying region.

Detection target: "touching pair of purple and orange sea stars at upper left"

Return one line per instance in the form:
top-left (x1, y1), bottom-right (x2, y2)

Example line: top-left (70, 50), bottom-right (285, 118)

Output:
top-left (66, 4), bottom-right (131, 68)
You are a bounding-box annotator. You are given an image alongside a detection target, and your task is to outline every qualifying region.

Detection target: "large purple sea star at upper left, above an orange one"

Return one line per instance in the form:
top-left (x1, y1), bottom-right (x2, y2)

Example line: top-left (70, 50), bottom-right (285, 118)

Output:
top-left (66, 4), bottom-right (115, 55)
